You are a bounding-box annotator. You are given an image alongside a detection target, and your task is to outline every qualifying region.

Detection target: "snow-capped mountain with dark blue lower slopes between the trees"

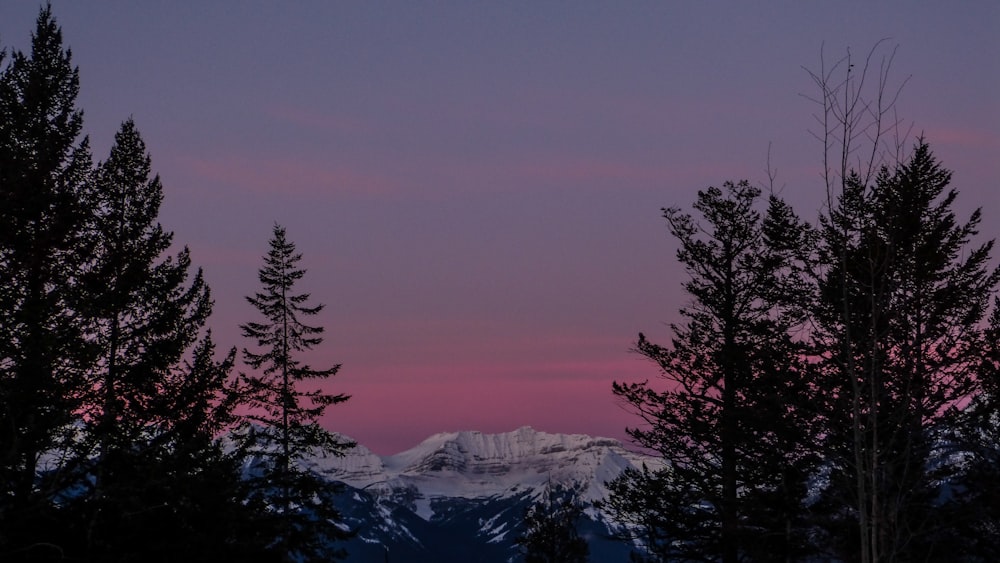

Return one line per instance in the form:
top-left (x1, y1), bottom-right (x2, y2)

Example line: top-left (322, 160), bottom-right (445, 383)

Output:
top-left (310, 427), bottom-right (658, 563)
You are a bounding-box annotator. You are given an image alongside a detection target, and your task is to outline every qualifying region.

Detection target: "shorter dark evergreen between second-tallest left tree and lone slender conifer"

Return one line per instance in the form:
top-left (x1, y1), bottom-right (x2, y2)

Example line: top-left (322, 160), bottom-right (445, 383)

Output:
top-left (91, 334), bottom-right (280, 563)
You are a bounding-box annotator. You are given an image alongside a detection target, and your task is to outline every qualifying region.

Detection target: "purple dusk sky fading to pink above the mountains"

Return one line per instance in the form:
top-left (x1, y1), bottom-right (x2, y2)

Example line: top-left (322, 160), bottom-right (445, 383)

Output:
top-left (0, 0), bottom-right (1000, 455)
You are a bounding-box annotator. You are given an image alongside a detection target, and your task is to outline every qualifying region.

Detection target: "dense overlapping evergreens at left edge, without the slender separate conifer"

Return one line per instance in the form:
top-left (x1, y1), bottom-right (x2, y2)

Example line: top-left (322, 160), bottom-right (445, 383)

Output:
top-left (0, 7), bottom-right (286, 561)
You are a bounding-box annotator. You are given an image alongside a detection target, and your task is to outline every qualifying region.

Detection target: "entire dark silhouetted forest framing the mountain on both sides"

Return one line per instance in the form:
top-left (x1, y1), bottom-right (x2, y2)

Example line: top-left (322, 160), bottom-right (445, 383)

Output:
top-left (0, 7), bottom-right (1000, 563)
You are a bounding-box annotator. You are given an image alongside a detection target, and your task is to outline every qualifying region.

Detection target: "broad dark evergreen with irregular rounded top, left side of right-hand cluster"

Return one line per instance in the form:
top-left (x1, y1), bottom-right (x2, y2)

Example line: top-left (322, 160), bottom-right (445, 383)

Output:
top-left (612, 182), bottom-right (814, 563)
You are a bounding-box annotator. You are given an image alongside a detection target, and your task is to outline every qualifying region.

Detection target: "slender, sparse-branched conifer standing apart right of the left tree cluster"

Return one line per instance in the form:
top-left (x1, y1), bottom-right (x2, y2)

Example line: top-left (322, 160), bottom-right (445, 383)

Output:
top-left (241, 224), bottom-right (353, 560)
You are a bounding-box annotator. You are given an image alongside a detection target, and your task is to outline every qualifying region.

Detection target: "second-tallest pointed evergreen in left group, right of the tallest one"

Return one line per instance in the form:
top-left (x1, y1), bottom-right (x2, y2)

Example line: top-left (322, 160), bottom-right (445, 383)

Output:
top-left (65, 119), bottom-right (267, 561)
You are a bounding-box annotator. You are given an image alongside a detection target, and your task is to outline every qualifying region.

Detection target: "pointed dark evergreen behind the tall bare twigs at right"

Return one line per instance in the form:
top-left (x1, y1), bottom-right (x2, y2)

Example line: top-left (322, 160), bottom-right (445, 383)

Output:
top-left (814, 139), bottom-right (1000, 561)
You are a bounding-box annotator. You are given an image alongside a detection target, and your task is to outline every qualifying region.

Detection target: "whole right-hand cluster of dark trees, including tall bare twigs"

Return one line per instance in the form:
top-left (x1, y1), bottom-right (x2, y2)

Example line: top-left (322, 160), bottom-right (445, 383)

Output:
top-left (605, 46), bottom-right (1000, 563)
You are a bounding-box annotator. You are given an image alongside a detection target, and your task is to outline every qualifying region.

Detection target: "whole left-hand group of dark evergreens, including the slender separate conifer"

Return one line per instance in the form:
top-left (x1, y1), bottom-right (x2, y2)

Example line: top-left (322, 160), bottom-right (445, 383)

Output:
top-left (0, 8), bottom-right (349, 562)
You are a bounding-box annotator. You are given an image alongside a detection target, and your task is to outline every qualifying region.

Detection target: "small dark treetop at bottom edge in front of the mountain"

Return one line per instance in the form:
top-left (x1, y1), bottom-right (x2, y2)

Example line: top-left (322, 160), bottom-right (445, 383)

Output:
top-left (515, 483), bottom-right (590, 563)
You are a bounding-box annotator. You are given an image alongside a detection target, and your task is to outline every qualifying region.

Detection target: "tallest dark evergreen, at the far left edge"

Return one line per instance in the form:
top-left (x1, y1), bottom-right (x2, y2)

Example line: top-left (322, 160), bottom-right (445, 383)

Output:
top-left (0, 7), bottom-right (91, 558)
